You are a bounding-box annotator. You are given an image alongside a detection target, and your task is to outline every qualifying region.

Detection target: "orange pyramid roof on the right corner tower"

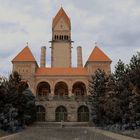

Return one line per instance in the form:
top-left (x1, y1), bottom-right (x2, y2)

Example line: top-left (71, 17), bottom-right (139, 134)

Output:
top-left (88, 46), bottom-right (112, 62)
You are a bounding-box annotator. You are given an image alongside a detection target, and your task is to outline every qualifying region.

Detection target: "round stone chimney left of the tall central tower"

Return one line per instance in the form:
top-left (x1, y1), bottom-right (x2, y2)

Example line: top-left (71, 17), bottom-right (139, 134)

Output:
top-left (40, 46), bottom-right (46, 68)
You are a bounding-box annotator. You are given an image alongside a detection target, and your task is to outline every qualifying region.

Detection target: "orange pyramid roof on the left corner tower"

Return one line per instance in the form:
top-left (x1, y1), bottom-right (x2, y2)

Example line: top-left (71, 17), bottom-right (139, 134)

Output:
top-left (12, 46), bottom-right (36, 62)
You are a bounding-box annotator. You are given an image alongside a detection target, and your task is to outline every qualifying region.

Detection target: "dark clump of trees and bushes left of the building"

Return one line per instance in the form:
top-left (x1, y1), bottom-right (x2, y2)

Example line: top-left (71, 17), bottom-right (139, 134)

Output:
top-left (0, 72), bottom-right (36, 131)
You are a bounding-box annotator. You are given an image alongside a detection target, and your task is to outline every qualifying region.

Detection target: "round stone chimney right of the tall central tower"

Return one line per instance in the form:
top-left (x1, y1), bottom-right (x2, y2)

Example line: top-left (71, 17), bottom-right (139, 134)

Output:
top-left (77, 46), bottom-right (83, 67)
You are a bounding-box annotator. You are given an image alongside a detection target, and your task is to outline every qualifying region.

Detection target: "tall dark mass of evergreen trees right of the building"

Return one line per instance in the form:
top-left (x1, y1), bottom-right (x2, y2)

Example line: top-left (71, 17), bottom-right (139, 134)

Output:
top-left (89, 53), bottom-right (140, 130)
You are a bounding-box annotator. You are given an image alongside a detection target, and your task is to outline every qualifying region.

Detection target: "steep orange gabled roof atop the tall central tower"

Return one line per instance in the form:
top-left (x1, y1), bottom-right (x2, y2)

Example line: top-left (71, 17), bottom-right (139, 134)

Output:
top-left (52, 7), bottom-right (71, 28)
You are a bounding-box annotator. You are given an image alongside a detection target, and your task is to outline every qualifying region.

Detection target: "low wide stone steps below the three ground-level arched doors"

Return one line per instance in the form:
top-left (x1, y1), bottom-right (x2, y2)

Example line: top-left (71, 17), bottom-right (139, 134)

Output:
top-left (30, 122), bottom-right (89, 128)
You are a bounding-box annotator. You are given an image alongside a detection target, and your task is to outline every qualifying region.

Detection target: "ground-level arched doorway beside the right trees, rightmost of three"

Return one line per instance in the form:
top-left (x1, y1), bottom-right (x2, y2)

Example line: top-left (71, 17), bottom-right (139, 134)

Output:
top-left (77, 106), bottom-right (89, 122)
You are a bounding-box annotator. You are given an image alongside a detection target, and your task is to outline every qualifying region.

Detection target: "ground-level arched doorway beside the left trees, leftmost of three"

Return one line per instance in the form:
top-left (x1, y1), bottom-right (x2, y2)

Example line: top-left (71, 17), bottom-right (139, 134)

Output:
top-left (36, 105), bottom-right (45, 122)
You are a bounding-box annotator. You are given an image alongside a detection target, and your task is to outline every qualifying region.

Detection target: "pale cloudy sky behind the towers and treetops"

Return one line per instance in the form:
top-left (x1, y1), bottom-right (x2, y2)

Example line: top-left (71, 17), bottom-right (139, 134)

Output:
top-left (0, 0), bottom-right (140, 76)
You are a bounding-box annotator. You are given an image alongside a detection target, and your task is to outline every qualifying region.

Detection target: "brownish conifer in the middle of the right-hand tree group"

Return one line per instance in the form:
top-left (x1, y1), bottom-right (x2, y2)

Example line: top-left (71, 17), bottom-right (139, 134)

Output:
top-left (104, 75), bottom-right (122, 125)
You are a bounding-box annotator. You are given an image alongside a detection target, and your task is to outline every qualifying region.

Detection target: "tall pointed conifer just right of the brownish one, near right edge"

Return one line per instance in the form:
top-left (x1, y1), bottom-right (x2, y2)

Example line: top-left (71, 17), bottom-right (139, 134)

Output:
top-left (114, 60), bottom-right (131, 123)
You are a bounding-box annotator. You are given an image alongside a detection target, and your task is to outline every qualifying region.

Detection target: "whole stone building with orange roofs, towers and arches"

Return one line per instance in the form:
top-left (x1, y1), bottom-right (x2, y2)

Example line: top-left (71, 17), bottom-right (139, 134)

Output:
top-left (12, 8), bottom-right (111, 122)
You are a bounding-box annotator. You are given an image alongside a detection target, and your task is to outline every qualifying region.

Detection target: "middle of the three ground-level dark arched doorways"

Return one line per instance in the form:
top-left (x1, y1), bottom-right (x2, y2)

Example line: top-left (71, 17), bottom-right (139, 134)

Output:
top-left (55, 106), bottom-right (67, 122)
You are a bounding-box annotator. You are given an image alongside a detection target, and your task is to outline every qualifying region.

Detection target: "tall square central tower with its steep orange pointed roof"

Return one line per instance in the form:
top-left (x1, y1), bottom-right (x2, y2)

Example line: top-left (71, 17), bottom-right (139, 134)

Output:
top-left (51, 8), bottom-right (72, 68)
